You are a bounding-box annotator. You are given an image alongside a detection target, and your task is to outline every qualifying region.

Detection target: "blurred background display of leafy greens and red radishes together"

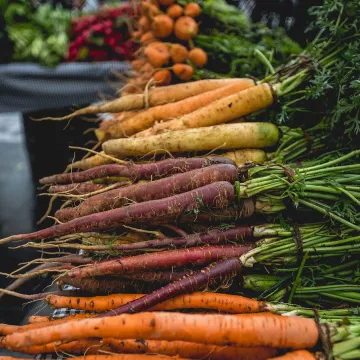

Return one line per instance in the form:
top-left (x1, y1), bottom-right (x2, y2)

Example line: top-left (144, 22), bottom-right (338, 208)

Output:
top-left (0, 0), bottom-right (138, 67)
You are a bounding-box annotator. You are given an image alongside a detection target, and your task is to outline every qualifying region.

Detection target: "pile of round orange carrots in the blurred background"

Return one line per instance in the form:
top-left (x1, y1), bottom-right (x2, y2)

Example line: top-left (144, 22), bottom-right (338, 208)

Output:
top-left (124, 0), bottom-right (207, 93)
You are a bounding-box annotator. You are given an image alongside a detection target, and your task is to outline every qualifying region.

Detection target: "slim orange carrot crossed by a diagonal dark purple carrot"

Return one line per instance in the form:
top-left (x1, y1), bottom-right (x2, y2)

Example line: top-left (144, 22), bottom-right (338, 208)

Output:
top-left (45, 292), bottom-right (272, 314)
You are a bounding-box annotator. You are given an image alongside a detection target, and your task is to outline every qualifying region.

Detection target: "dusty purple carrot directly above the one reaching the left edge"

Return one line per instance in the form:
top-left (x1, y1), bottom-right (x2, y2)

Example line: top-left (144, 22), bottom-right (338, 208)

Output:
top-left (55, 164), bottom-right (237, 222)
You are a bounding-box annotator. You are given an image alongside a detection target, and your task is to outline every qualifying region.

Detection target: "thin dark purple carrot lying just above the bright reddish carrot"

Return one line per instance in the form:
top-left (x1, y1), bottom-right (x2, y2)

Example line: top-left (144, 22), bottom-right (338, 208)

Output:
top-left (78, 225), bottom-right (253, 251)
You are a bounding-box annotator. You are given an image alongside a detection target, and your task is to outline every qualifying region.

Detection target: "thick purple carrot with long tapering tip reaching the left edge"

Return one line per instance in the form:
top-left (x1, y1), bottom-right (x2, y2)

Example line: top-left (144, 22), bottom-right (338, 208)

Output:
top-left (0, 181), bottom-right (235, 244)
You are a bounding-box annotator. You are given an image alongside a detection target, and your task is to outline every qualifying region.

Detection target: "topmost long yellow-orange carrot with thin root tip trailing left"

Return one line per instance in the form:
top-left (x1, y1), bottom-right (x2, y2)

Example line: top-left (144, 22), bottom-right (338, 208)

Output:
top-left (37, 79), bottom-right (246, 120)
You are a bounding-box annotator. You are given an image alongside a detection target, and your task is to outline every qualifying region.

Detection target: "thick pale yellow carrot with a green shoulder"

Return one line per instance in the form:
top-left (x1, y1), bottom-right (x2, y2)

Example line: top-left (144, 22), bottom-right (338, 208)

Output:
top-left (102, 122), bottom-right (279, 156)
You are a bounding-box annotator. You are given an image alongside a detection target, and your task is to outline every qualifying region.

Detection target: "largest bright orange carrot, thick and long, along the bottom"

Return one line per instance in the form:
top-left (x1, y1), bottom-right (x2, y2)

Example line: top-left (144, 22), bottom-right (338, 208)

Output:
top-left (3, 312), bottom-right (319, 350)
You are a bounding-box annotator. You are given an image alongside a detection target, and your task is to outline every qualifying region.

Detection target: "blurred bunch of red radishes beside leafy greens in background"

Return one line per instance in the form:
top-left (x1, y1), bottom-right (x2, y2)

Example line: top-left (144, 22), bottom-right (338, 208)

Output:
top-left (67, 3), bottom-right (137, 61)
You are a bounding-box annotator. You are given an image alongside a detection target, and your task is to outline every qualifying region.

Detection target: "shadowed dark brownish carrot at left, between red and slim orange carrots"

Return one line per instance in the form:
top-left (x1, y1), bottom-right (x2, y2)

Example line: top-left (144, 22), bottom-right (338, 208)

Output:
top-left (57, 276), bottom-right (144, 294)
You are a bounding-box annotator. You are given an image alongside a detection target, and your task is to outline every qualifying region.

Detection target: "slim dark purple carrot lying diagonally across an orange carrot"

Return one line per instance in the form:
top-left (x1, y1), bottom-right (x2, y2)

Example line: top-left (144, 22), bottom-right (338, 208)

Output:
top-left (98, 258), bottom-right (241, 317)
